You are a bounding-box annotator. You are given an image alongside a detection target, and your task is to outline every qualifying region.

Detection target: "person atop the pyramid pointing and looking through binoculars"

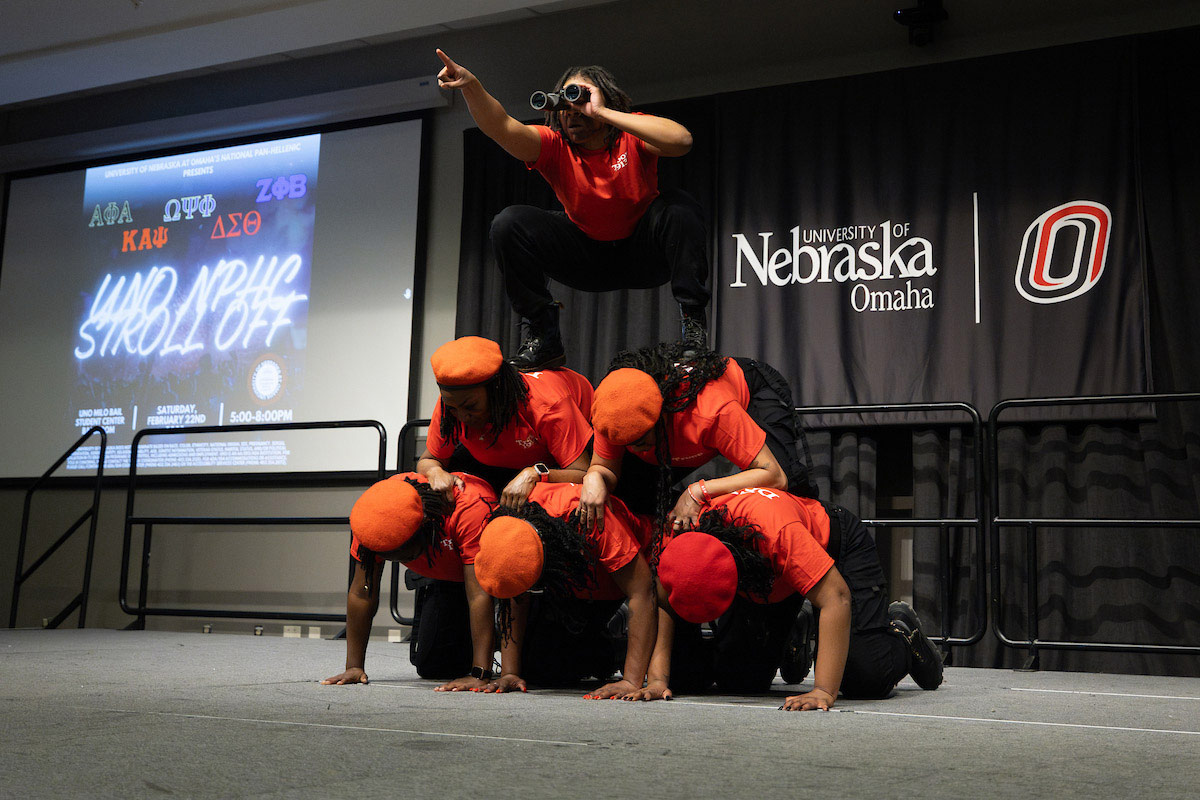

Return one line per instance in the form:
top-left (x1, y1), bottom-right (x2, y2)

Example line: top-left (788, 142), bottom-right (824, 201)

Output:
top-left (437, 50), bottom-right (710, 371)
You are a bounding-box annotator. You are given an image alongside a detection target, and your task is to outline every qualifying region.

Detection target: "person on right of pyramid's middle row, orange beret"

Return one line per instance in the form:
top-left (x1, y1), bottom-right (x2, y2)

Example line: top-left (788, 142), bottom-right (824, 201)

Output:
top-left (582, 343), bottom-right (816, 530)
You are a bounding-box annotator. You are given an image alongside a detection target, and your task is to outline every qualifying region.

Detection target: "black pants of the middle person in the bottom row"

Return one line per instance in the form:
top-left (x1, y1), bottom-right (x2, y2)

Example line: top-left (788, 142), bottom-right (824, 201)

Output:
top-left (521, 594), bottom-right (622, 686)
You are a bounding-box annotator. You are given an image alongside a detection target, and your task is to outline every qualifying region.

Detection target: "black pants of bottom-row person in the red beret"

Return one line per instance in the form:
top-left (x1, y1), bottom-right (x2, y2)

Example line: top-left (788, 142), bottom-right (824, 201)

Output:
top-left (671, 506), bottom-right (908, 699)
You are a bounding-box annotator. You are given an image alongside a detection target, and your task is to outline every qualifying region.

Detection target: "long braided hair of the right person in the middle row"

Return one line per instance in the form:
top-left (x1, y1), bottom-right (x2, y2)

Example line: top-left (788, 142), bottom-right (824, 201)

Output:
top-left (608, 342), bottom-right (727, 556)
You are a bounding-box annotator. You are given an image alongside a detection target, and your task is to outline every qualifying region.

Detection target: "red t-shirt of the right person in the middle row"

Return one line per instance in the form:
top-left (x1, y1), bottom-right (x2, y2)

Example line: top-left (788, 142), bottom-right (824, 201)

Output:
top-left (593, 367), bottom-right (767, 469)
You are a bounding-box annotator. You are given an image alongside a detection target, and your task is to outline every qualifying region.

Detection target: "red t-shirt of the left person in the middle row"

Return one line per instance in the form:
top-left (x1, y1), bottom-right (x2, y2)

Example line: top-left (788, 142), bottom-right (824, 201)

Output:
top-left (425, 368), bottom-right (593, 469)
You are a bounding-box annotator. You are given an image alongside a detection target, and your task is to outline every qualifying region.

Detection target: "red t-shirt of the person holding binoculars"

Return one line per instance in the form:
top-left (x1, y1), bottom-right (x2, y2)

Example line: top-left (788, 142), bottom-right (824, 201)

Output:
top-left (526, 125), bottom-right (659, 241)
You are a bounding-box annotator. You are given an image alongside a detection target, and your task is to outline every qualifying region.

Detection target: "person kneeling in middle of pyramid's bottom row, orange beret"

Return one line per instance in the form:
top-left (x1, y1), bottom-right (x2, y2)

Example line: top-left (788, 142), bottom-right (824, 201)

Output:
top-left (475, 483), bottom-right (658, 699)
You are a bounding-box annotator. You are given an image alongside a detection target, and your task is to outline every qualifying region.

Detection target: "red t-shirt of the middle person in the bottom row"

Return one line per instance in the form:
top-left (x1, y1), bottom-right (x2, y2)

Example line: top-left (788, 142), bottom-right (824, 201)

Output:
top-left (529, 483), bottom-right (650, 600)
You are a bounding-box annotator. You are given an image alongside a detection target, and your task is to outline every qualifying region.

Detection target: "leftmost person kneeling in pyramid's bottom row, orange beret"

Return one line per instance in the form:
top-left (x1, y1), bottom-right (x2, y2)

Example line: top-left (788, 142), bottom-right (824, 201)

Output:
top-left (320, 473), bottom-right (496, 691)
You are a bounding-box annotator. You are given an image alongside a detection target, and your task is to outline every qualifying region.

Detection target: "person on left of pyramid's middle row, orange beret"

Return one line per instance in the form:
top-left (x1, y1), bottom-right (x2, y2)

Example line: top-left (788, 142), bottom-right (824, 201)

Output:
top-left (416, 336), bottom-right (593, 506)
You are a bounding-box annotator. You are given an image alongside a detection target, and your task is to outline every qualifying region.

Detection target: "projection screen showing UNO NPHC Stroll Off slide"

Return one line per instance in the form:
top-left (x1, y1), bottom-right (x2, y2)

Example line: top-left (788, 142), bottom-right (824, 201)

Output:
top-left (0, 119), bottom-right (421, 477)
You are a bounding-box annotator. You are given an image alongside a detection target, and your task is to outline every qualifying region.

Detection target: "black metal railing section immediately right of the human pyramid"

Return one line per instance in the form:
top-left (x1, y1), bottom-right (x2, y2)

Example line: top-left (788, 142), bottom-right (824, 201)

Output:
top-left (796, 402), bottom-right (988, 648)
